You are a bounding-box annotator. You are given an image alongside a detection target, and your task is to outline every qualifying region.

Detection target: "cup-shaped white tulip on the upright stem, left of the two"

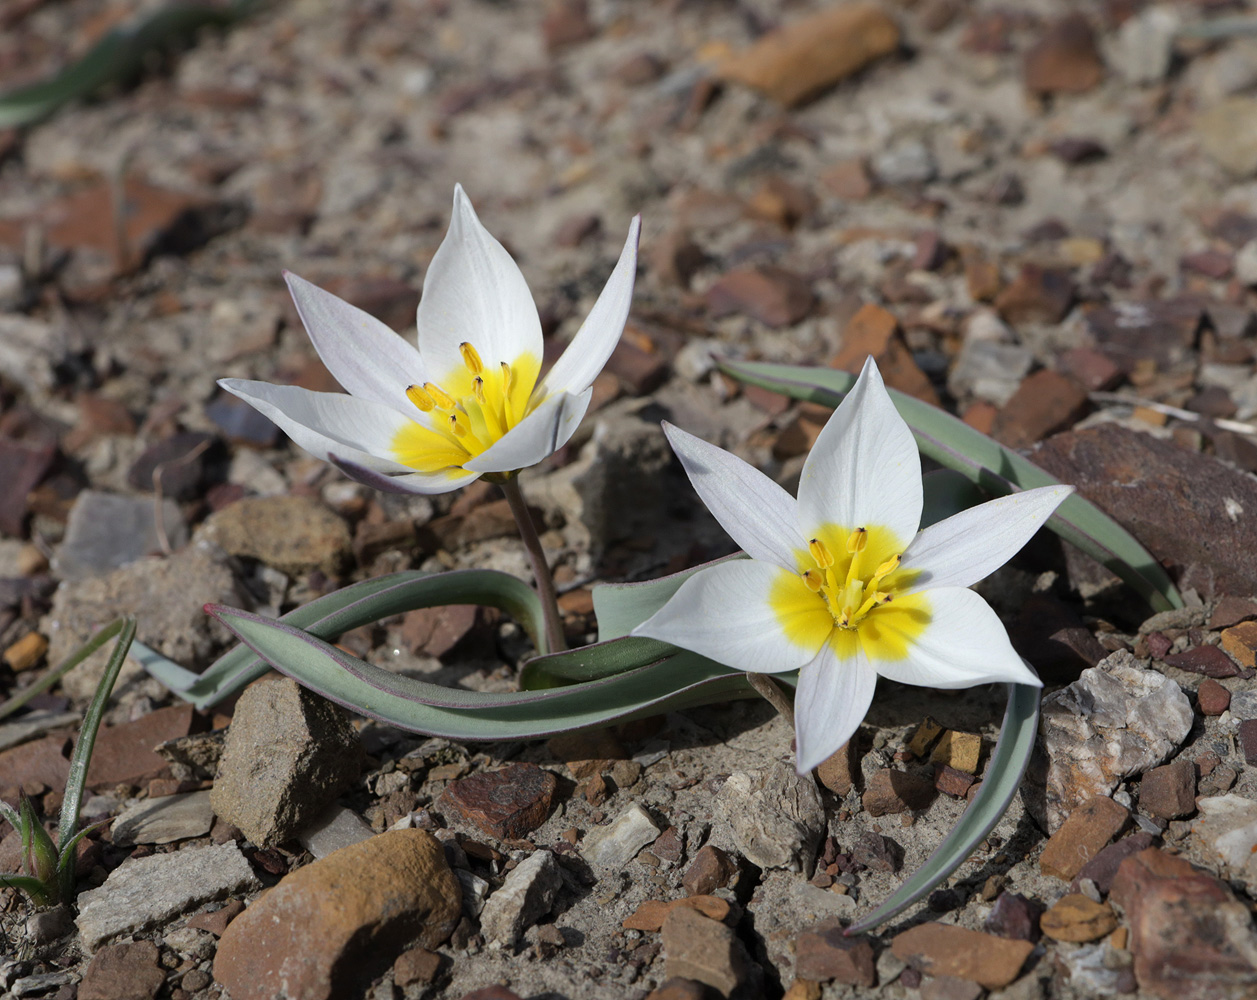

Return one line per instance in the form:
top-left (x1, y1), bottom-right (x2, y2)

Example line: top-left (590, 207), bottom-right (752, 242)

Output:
top-left (219, 186), bottom-right (641, 494)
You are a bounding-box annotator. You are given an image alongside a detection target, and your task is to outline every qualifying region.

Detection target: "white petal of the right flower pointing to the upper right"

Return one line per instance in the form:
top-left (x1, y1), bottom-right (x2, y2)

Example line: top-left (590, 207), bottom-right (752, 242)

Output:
top-left (903, 486), bottom-right (1073, 593)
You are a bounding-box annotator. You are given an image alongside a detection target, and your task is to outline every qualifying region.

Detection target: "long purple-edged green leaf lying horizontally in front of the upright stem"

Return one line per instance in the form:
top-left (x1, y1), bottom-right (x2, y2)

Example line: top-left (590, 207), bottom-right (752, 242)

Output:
top-left (212, 608), bottom-right (793, 741)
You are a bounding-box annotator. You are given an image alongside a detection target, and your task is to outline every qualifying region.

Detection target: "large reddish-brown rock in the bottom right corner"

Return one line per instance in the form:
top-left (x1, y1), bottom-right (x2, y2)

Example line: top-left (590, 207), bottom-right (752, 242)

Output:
top-left (1112, 848), bottom-right (1257, 1000)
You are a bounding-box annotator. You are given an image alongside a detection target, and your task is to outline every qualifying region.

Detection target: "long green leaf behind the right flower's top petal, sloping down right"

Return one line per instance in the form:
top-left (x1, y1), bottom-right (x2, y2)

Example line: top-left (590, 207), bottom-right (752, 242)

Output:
top-left (719, 361), bottom-right (1183, 611)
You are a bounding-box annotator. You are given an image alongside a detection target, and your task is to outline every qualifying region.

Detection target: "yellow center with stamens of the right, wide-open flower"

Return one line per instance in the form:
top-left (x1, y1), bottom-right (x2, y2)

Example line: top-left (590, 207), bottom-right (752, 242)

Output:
top-left (769, 525), bottom-right (930, 660)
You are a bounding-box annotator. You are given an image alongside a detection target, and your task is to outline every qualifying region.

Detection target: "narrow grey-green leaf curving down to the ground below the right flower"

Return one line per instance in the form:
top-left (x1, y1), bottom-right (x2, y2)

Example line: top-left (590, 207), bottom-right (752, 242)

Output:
top-left (845, 685), bottom-right (1041, 935)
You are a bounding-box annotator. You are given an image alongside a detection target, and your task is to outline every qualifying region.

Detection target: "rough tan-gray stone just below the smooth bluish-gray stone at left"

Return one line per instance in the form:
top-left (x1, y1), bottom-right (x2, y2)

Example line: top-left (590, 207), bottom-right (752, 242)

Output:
top-left (39, 544), bottom-right (251, 700)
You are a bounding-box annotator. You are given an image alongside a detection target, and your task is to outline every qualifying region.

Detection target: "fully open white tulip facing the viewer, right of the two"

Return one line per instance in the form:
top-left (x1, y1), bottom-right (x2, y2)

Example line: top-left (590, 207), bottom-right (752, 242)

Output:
top-left (634, 358), bottom-right (1073, 774)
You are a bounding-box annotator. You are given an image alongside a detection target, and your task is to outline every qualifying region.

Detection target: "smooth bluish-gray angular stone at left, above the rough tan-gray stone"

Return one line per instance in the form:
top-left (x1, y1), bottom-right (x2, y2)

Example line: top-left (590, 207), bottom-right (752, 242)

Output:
top-left (53, 490), bottom-right (187, 580)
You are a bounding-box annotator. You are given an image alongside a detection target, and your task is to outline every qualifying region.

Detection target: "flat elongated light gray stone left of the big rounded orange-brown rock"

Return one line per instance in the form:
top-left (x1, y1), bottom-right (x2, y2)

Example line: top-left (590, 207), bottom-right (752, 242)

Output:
top-left (77, 843), bottom-right (261, 951)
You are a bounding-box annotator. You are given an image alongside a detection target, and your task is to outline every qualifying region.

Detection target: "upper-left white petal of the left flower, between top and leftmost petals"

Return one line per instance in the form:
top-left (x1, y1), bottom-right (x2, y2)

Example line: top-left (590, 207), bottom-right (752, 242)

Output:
top-left (284, 271), bottom-right (427, 412)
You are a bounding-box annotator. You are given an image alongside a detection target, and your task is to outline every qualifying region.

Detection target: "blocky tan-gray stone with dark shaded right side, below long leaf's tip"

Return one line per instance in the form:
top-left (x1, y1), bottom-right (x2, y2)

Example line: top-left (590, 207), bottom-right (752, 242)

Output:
top-left (210, 677), bottom-right (362, 844)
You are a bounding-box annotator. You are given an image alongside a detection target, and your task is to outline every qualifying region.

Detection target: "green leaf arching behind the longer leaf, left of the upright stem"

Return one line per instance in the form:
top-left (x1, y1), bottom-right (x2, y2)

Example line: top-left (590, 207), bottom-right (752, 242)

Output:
top-left (140, 569), bottom-right (546, 709)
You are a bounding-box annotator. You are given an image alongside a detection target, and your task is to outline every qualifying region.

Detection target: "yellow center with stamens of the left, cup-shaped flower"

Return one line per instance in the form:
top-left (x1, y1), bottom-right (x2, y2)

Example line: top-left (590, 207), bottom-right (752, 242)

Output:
top-left (392, 342), bottom-right (541, 474)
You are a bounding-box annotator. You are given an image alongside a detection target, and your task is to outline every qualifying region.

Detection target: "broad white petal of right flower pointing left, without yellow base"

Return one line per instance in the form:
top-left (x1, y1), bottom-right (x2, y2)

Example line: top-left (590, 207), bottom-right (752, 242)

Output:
top-left (632, 559), bottom-right (816, 673)
